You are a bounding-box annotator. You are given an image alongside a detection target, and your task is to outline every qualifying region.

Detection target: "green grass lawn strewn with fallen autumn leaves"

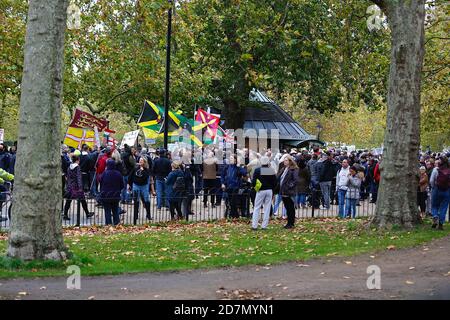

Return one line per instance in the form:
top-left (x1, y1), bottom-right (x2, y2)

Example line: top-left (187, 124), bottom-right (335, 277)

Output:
top-left (0, 219), bottom-right (450, 278)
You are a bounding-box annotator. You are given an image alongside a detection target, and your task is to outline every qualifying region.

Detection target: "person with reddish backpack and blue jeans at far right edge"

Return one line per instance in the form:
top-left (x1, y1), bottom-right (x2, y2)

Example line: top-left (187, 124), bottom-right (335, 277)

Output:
top-left (430, 156), bottom-right (450, 230)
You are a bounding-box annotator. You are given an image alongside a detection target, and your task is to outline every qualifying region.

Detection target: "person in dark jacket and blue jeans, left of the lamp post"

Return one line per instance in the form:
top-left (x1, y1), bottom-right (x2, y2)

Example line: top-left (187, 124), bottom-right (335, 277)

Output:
top-left (128, 157), bottom-right (152, 221)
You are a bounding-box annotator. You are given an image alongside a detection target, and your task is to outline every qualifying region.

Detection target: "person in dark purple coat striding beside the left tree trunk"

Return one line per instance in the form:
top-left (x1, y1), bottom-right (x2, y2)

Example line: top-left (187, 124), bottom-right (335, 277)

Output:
top-left (63, 156), bottom-right (94, 221)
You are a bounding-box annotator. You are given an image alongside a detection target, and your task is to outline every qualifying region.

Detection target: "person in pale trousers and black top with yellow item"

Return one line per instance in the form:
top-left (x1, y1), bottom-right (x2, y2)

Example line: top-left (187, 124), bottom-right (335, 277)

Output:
top-left (252, 156), bottom-right (277, 230)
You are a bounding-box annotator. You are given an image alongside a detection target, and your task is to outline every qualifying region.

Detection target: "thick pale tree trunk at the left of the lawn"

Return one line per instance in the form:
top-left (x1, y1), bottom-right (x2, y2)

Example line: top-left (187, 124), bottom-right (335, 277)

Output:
top-left (8, 0), bottom-right (68, 260)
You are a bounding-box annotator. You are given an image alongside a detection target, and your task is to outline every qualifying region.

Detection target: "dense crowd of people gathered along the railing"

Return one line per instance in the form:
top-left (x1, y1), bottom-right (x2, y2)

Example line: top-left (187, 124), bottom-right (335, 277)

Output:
top-left (0, 144), bottom-right (450, 230)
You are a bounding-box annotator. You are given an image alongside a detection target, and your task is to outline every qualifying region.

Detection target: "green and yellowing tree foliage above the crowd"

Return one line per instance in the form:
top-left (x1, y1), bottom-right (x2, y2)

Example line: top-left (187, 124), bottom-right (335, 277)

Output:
top-left (0, 0), bottom-right (450, 145)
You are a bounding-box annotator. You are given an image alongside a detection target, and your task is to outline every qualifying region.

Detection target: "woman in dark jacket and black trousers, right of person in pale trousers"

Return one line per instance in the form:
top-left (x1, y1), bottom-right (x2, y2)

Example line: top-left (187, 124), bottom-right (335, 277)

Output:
top-left (278, 155), bottom-right (299, 229)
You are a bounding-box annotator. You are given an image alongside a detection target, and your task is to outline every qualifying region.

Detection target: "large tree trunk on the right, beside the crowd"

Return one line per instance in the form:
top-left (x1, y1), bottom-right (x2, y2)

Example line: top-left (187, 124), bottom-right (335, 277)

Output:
top-left (373, 0), bottom-right (425, 227)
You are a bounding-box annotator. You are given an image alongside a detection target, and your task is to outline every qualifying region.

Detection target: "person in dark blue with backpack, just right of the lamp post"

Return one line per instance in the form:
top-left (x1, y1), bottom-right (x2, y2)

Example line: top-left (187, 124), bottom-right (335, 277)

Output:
top-left (166, 161), bottom-right (186, 220)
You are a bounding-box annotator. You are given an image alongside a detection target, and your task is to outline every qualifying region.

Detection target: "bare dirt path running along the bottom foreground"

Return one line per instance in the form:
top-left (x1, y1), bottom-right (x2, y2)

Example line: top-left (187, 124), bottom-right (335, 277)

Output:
top-left (0, 237), bottom-right (450, 299)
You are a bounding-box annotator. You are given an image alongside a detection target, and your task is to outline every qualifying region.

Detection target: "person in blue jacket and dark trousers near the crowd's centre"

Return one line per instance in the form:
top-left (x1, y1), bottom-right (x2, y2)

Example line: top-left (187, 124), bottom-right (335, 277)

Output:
top-left (221, 155), bottom-right (247, 218)
